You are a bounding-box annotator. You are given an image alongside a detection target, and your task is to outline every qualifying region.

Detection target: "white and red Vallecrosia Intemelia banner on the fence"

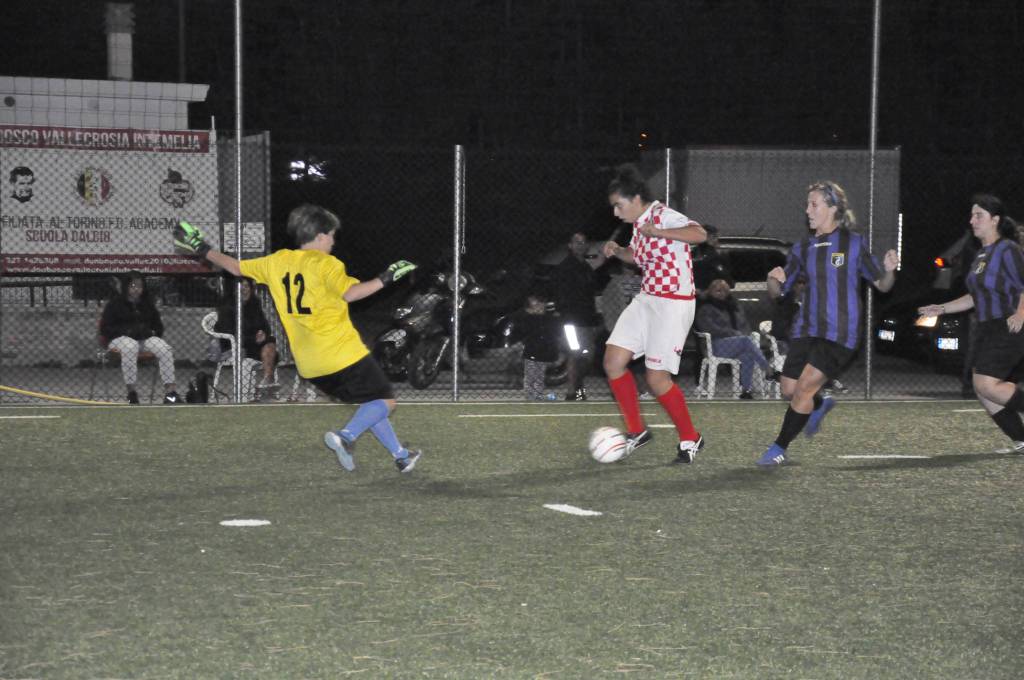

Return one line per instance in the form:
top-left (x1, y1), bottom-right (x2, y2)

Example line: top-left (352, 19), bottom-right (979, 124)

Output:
top-left (0, 125), bottom-right (220, 273)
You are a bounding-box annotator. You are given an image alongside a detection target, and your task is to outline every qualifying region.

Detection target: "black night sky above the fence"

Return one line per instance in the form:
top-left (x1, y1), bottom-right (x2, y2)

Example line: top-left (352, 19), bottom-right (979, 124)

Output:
top-left (0, 0), bottom-right (1024, 284)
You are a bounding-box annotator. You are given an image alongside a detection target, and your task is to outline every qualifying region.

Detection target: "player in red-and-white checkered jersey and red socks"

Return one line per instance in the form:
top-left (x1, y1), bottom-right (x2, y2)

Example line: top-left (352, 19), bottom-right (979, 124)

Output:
top-left (604, 165), bottom-right (708, 463)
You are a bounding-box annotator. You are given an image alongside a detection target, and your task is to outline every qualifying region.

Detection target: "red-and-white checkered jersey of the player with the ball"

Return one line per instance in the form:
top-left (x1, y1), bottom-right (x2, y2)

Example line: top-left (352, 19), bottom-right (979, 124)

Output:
top-left (630, 201), bottom-right (694, 297)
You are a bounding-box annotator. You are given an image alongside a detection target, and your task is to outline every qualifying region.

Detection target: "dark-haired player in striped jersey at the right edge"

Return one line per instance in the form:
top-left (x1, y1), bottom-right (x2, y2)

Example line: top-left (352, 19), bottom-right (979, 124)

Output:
top-left (918, 194), bottom-right (1024, 454)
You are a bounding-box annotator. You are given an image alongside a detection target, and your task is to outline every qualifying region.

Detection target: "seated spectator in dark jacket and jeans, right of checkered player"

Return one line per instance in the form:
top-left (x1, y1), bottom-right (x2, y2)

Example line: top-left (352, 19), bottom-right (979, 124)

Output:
top-left (696, 279), bottom-right (778, 399)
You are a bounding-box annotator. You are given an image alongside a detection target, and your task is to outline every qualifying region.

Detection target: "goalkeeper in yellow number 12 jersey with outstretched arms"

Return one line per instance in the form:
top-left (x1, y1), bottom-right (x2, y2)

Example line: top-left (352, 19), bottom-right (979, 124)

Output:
top-left (174, 205), bottom-right (421, 472)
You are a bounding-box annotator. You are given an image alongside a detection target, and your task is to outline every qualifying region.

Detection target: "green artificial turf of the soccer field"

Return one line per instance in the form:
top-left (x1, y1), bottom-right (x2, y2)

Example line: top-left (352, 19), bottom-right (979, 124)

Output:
top-left (0, 401), bottom-right (1024, 679)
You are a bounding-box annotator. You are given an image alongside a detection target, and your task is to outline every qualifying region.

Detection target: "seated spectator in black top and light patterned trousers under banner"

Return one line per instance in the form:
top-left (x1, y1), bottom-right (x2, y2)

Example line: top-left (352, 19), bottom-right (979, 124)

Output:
top-left (99, 271), bottom-right (181, 403)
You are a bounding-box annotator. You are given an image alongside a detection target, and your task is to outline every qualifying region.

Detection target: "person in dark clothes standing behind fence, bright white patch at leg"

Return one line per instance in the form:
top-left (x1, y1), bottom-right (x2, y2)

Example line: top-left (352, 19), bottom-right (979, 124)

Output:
top-left (552, 231), bottom-right (604, 401)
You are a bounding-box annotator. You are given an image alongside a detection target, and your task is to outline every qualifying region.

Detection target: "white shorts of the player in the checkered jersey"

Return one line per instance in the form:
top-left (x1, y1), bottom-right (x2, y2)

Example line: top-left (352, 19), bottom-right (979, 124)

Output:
top-left (606, 293), bottom-right (696, 373)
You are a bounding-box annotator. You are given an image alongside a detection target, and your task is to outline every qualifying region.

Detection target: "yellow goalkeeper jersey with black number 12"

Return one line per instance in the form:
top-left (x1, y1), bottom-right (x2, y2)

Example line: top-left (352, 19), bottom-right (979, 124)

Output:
top-left (239, 250), bottom-right (370, 378)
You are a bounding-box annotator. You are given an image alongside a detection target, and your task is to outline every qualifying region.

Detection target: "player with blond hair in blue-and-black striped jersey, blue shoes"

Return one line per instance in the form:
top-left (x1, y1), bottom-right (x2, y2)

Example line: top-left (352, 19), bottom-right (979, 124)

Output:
top-left (758, 181), bottom-right (899, 466)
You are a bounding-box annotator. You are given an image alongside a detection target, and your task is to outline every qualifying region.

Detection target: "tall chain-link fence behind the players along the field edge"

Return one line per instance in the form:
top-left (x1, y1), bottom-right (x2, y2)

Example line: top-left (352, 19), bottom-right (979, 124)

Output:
top-left (0, 134), bottom-right (999, 403)
